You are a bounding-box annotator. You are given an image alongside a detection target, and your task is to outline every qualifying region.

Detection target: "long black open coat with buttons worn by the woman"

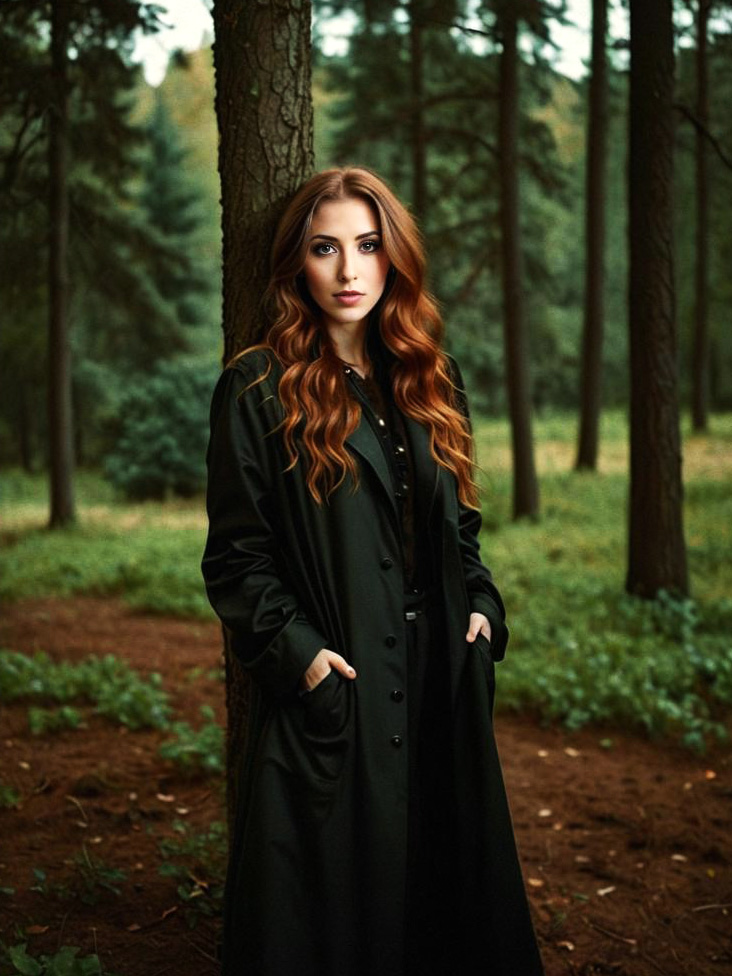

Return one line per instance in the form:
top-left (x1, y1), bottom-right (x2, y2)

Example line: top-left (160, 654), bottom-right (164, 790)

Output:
top-left (203, 350), bottom-right (542, 976)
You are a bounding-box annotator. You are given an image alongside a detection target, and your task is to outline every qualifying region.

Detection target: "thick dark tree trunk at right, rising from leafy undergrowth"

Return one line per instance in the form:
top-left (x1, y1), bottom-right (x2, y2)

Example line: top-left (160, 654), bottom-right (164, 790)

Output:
top-left (626, 0), bottom-right (688, 597)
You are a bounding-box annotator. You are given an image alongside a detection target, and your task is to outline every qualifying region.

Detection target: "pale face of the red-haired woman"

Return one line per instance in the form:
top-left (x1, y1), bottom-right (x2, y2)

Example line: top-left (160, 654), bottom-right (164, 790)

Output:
top-left (303, 197), bottom-right (389, 335)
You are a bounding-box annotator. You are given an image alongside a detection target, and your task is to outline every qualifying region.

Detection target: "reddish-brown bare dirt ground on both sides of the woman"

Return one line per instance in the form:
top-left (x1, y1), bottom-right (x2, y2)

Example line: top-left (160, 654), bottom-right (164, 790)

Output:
top-left (0, 597), bottom-right (732, 976)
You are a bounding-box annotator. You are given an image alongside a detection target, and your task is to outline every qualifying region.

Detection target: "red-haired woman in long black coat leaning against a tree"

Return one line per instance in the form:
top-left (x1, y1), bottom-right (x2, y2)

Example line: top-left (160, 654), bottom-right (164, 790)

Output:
top-left (203, 168), bottom-right (542, 976)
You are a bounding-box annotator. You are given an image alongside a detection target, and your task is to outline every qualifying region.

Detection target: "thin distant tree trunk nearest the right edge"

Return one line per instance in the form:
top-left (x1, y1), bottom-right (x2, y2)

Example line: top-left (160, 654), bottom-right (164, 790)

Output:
top-left (691, 0), bottom-right (711, 431)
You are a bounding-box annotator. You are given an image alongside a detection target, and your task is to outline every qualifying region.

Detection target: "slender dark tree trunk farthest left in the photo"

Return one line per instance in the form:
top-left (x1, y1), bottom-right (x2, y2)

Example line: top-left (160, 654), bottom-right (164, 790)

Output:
top-left (48, 0), bottom-right (76, 528)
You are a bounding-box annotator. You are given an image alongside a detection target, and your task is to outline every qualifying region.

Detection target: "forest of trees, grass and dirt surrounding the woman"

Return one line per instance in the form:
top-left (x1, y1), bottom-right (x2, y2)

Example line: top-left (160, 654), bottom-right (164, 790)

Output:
top-left (0, 0), bottom-right (732, 976)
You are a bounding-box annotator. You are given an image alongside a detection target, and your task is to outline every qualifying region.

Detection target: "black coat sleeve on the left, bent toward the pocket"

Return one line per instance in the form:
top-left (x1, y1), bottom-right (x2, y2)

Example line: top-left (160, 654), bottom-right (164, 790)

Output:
top-left (201, 367), bottom-right (328, 698)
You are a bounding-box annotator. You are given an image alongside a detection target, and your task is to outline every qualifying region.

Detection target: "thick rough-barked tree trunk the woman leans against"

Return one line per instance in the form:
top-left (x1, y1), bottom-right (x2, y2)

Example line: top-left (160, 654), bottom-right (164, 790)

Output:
top-left (213, 0), bottom-right (313, 827)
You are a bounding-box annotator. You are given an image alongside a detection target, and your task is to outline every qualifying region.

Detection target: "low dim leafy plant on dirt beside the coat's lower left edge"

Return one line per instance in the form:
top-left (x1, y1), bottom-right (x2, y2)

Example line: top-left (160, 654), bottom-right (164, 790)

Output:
top-left (158, 820), bottom-right (228, 928)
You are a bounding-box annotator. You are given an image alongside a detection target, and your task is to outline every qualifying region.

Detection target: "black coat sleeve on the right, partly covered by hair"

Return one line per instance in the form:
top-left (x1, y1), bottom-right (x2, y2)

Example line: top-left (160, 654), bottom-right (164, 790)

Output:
top-left (448, 356), bottom-right (508, 661)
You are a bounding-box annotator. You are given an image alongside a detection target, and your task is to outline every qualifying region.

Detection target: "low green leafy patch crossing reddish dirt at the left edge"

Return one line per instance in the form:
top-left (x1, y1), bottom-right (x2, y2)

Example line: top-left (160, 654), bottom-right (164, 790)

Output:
top-left (0, 651), bottom-right (170, 733)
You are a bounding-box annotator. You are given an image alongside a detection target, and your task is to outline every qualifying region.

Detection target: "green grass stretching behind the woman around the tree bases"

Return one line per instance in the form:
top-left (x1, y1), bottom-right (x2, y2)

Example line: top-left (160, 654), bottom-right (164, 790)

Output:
top-left (0, 412), bottom-right (732, 748)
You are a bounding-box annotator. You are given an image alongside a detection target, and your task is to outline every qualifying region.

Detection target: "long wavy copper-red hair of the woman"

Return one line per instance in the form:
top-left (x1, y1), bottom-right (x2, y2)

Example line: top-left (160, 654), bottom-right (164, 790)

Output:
top-left (237, 167), bottom-right (478, 507)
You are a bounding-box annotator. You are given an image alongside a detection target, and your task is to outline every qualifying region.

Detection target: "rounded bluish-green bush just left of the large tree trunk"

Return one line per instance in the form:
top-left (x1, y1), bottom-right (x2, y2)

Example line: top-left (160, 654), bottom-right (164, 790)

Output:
top-left (105, 362), bottom-right (214, 500)
